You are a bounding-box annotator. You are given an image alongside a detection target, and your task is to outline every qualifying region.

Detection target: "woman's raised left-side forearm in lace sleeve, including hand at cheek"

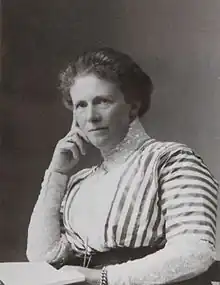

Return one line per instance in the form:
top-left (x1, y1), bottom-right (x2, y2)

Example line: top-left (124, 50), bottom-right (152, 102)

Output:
top-left (27, 120), bottom-right (87, 263)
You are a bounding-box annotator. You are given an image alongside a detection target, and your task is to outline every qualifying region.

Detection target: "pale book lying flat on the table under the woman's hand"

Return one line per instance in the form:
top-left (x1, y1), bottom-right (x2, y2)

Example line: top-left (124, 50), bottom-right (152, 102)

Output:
top-left (0, 262), bottom-right (85, 285)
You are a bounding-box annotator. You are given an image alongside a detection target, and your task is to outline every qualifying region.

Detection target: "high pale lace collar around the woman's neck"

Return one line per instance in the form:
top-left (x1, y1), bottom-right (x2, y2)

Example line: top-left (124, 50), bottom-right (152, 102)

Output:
top-left (99, 118), bottom-right (150, 171)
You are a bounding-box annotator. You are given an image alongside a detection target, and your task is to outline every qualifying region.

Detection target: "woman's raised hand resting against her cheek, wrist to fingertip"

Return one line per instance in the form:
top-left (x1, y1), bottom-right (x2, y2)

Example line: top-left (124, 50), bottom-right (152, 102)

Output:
top-left (49, 122), bottom-right (89, 175)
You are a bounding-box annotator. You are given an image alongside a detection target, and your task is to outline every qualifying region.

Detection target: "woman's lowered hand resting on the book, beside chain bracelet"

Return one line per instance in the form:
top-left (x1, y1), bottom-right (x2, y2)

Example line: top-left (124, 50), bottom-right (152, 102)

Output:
top-left (62, 266), bottom-right (101, 285)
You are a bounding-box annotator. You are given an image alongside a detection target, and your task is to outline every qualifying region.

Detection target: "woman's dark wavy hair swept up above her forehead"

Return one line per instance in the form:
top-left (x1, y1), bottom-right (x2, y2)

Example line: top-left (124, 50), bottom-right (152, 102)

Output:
top-left (59, 47), bottom-right (153, 117)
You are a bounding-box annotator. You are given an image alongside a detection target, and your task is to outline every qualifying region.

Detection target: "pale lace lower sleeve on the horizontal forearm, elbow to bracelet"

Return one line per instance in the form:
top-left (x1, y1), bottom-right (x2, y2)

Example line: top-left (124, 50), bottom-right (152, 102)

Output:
top-left (107, 236), bottom-right (215, 285)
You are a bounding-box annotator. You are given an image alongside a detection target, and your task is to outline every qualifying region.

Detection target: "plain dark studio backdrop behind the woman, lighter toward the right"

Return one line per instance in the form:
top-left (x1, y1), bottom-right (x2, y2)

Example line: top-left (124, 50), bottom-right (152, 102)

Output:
top-left (0, 0), bottom-right (220, 261)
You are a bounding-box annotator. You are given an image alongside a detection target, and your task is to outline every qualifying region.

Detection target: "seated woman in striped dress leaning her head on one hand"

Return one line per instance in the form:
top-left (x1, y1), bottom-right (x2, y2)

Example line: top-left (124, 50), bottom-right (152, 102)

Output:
top-left (27, 48), bottom-right (218, 285)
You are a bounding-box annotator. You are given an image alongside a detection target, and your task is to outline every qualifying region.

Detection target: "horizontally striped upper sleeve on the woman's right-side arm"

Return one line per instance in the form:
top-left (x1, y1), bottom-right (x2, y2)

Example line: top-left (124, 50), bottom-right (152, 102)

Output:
top-left (159, 147), bottom-right (218, 245)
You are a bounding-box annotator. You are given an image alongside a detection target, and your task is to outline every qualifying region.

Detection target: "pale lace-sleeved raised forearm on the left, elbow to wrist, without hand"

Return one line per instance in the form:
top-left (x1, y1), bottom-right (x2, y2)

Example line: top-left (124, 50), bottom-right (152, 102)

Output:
top-left (27, 170), bottom-right (69, 263)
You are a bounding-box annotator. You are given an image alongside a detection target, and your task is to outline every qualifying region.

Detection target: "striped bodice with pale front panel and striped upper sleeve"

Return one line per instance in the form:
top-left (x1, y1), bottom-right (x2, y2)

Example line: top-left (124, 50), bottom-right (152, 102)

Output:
top-left (61, 139), bottom-right (218, 253)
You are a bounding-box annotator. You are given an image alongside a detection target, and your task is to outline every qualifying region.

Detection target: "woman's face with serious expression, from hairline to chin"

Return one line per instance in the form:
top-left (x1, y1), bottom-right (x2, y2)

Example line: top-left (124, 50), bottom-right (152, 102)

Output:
top-left (70, 74), bottom-right (131, 149)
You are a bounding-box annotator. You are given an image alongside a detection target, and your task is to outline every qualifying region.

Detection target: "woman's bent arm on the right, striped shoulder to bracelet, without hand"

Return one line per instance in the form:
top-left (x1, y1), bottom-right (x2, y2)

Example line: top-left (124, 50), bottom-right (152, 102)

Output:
top-left (107, 145), bottom-right (218, 285)
